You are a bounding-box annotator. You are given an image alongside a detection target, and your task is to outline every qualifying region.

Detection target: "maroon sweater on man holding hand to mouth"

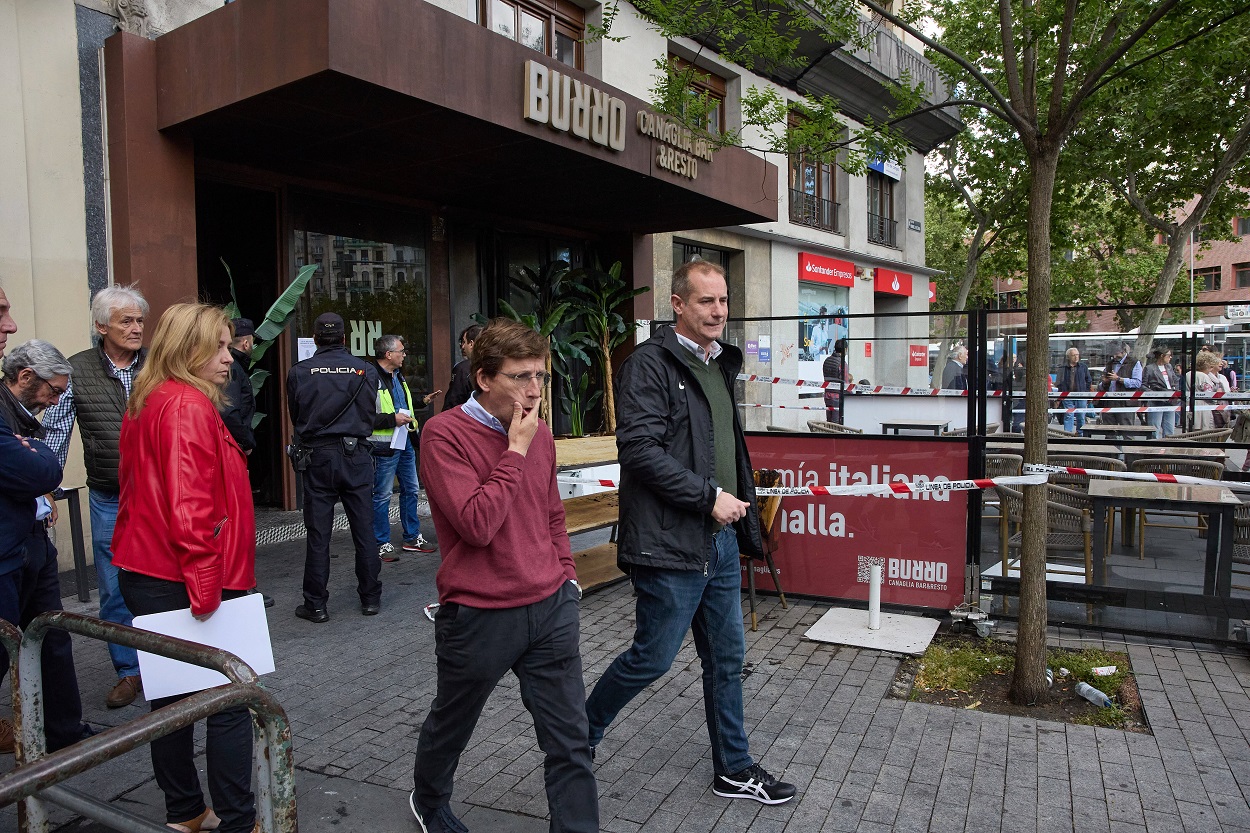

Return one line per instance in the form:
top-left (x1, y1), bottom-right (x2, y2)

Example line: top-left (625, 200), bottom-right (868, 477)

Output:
top-left (421, 408), bottom-right (578, 608)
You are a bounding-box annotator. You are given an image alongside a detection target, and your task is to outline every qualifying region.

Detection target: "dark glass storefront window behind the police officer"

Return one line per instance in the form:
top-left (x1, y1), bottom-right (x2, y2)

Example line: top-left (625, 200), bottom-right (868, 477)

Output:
top-left (293, 224), bottom-right (434, 394)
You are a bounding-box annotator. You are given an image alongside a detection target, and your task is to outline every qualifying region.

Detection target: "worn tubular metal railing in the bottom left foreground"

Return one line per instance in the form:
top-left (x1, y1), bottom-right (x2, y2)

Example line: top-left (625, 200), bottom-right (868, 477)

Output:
top-left (0, 610), bottom-right (299, 833)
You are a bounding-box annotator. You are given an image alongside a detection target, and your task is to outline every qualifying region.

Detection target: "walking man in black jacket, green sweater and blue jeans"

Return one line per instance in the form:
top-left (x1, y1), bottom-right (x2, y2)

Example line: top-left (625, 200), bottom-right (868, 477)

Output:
top-left (586, 260), bottom-right (795, 804)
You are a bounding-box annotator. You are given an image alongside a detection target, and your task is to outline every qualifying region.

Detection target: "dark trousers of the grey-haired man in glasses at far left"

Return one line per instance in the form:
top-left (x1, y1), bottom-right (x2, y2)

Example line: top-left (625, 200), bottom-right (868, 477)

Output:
top-left (0, 523), bottom-right (83, 752)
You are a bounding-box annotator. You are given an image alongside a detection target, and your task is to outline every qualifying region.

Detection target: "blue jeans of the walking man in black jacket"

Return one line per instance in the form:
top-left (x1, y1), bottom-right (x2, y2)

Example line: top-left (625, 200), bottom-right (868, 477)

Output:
top-left (586, 528), bottom-right (754, 775)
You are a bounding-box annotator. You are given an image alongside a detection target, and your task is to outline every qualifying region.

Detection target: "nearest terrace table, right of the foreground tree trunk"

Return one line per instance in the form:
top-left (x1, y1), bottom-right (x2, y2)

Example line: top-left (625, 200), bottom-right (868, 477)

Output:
top-left (1090, 480), bottom-right (1241, 597)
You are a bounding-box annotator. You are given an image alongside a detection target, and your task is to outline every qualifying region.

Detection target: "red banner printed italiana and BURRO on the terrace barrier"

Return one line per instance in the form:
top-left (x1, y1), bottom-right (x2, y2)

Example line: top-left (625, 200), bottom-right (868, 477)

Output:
top-left (743, 434), bottom-right (969, 609)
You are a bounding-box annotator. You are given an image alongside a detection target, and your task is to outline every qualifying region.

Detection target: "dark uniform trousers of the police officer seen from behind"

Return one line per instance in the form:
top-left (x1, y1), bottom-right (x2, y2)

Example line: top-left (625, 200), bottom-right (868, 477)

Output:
top-left (304, 440), bottom-right (383, 608)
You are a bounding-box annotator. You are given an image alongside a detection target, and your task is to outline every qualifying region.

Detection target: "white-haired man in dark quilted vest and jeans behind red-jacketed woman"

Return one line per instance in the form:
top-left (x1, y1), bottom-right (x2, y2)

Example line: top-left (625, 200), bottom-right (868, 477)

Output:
top-left (44, 285), bottom-right (148, 709)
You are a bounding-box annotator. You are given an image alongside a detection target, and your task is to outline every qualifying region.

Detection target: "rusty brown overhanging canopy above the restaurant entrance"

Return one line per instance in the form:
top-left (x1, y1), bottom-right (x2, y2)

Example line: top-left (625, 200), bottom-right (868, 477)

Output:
top-left (156, 0), bottom-right (778, 233)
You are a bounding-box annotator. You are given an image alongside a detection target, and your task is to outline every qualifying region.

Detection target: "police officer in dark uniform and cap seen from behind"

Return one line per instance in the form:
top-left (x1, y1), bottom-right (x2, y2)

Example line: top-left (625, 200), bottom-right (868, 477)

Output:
top-left (286, 313), bottom-right (383, 623)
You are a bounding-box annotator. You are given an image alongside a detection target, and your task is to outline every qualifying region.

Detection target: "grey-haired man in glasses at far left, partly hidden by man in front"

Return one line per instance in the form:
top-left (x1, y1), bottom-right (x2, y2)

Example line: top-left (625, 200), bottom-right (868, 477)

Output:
top-left (0, 332), bottom-right (94, 753)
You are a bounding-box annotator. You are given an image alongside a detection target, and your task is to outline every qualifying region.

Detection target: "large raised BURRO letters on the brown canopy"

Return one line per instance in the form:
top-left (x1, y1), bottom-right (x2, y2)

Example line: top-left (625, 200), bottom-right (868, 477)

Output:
top-left (525, 61), bottom-right (626, 150)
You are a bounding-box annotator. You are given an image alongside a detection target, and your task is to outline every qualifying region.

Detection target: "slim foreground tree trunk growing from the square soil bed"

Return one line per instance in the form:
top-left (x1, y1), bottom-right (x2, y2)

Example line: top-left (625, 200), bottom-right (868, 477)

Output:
top-left (1003, 143), bottom-right (1060, 704)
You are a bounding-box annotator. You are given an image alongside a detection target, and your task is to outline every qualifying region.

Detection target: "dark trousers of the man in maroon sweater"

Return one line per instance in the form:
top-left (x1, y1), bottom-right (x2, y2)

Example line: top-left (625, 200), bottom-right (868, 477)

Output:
top-left (415, 582), bottom-right (599, 833)
